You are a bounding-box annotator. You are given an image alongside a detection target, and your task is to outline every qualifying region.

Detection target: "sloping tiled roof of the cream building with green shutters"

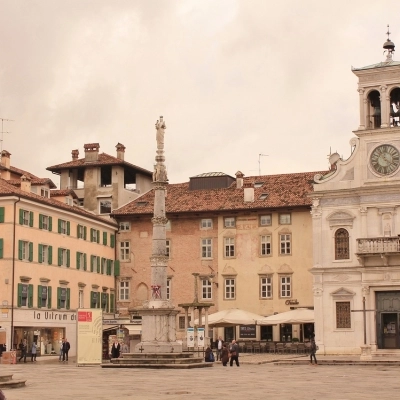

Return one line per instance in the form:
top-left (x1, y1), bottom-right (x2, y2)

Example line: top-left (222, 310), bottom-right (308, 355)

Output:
top-left (0, 179), bottom-right (116, 226)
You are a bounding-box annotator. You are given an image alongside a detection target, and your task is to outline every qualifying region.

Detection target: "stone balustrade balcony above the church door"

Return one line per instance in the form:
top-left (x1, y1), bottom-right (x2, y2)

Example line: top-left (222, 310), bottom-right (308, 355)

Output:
top-left (356, 236), bottom-right (400, 266)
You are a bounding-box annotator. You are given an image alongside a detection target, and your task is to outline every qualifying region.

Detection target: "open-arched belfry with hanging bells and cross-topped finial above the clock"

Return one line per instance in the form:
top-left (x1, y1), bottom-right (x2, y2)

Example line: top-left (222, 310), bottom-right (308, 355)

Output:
top-left (352, 25), bottom-right (400, 131)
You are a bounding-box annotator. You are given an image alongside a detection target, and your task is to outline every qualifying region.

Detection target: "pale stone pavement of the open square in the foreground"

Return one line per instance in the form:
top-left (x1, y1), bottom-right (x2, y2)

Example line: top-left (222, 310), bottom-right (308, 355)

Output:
top-left (0, 354), bottom-right (400, 400)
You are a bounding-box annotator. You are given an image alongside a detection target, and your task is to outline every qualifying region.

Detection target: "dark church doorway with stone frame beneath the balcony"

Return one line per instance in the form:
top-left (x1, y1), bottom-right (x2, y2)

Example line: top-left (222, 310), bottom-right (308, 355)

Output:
top-left (376, 291), bottom-right (400, 349)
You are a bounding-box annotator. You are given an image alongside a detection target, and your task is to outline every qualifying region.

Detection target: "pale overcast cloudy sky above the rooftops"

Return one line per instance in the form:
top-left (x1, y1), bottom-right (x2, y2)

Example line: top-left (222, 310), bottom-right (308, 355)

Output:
top-left (0, 0), bottom-right (400, 186)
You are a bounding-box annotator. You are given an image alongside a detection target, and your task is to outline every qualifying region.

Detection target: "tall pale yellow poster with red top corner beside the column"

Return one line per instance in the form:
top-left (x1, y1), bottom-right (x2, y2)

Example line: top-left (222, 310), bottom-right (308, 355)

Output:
top-left (76, 309), bottom-right (103, 366)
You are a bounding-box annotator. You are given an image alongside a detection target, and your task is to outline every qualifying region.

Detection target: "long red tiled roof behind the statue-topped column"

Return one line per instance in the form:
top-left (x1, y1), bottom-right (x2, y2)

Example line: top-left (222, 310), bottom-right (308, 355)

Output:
top-left (112, 172), bottom-right (321, 216)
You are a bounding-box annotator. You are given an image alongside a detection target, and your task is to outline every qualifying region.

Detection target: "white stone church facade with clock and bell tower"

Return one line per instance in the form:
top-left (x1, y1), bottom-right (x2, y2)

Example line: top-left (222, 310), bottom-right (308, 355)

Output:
top-left (311, 30), bottom-right (400, 359)
